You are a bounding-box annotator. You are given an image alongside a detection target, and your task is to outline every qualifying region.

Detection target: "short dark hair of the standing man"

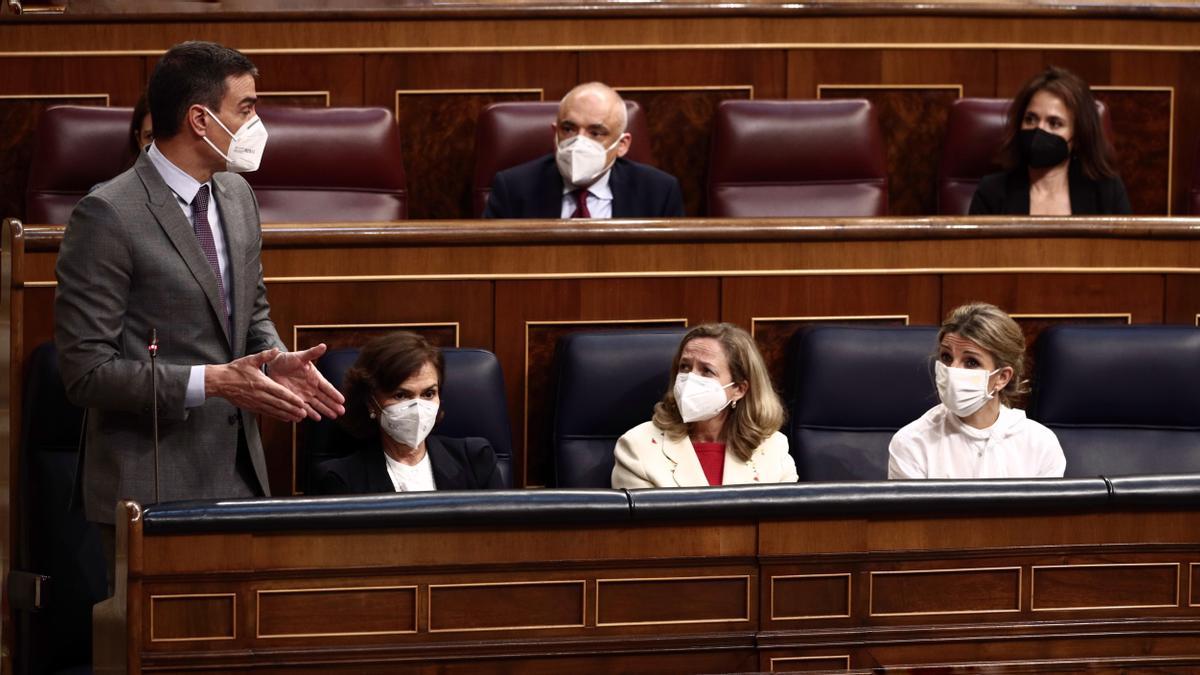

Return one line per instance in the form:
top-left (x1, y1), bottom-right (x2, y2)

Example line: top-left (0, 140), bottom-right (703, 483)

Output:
top-left (146, 42), bottom-right (258, 139)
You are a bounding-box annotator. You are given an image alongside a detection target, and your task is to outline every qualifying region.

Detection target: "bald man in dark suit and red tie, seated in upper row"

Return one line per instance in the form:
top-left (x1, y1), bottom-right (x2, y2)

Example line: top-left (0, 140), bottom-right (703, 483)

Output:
top-left (484, 82), bottom-right (683, 219)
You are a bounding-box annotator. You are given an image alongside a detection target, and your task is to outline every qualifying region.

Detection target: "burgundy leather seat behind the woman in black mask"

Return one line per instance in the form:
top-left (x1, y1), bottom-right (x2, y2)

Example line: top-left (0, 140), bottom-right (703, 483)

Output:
top-left (937, 98), bottom-right (1112, 215)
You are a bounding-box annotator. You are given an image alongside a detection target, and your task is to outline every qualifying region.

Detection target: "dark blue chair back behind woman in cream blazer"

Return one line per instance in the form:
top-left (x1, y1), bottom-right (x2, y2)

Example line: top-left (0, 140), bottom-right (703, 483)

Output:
top-left (553, 328), bottom-right (688, 488)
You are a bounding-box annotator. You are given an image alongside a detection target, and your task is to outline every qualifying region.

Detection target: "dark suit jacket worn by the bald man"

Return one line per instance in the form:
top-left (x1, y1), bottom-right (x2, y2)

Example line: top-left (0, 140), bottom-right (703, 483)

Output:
top-left (484, 153), bottom-right (683, 219)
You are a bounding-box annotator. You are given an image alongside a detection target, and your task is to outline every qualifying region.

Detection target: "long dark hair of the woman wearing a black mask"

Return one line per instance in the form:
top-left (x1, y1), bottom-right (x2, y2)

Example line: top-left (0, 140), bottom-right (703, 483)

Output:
top-left (1001, 66), bottom-right (1117, 180)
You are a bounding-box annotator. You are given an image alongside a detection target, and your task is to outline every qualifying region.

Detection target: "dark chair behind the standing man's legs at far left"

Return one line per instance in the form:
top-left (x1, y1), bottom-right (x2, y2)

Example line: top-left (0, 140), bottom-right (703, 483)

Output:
top-left (13, 342), bottom-right (108, 673)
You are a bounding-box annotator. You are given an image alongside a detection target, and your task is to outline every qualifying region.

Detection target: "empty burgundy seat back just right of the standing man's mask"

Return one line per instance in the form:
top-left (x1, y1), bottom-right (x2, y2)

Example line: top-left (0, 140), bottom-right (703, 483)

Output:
top-left (245, 106), bottom-right (408, 222)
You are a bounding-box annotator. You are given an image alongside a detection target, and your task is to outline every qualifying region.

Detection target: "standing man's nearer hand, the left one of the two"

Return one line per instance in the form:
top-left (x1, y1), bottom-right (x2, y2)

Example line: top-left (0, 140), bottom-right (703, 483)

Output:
top-left (204, 350), bottom-right (316, 422)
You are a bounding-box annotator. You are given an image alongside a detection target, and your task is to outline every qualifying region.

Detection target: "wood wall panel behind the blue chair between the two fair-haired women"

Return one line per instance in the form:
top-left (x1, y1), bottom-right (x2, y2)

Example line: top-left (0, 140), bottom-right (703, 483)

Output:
top-left (721, 274), bottom-right (941, 392)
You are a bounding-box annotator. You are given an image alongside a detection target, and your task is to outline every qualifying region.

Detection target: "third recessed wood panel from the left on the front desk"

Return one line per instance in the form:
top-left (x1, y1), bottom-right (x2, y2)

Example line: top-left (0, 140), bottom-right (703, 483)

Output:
top-left (430, 581), bottom-right (586, 632)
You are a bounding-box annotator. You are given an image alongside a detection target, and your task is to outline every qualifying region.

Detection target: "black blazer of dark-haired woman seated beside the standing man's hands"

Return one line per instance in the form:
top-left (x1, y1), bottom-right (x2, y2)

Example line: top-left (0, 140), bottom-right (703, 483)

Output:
top-left (313, 436), bottom-right (504, 495)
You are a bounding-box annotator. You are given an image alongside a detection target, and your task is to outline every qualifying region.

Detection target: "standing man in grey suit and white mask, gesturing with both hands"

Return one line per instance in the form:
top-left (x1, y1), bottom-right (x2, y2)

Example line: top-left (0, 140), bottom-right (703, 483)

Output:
top-left (54, 42), bottom-right (343, 560)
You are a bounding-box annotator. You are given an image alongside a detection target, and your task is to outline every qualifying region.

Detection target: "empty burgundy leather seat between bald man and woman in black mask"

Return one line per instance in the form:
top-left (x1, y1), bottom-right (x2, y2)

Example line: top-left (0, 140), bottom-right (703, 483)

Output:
top-left (708, 100), bottom-right (888, 217)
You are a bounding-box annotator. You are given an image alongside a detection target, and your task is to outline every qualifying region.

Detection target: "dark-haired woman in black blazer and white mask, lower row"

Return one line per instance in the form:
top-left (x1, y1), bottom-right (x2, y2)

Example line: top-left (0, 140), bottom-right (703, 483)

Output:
top-left (316, 333), bottom-right (504, 495)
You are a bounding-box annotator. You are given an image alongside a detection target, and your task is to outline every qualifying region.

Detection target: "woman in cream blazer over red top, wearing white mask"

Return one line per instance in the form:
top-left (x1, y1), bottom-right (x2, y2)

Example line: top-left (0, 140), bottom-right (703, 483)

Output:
top-left (612, 323), bottom-right (797, 488)
